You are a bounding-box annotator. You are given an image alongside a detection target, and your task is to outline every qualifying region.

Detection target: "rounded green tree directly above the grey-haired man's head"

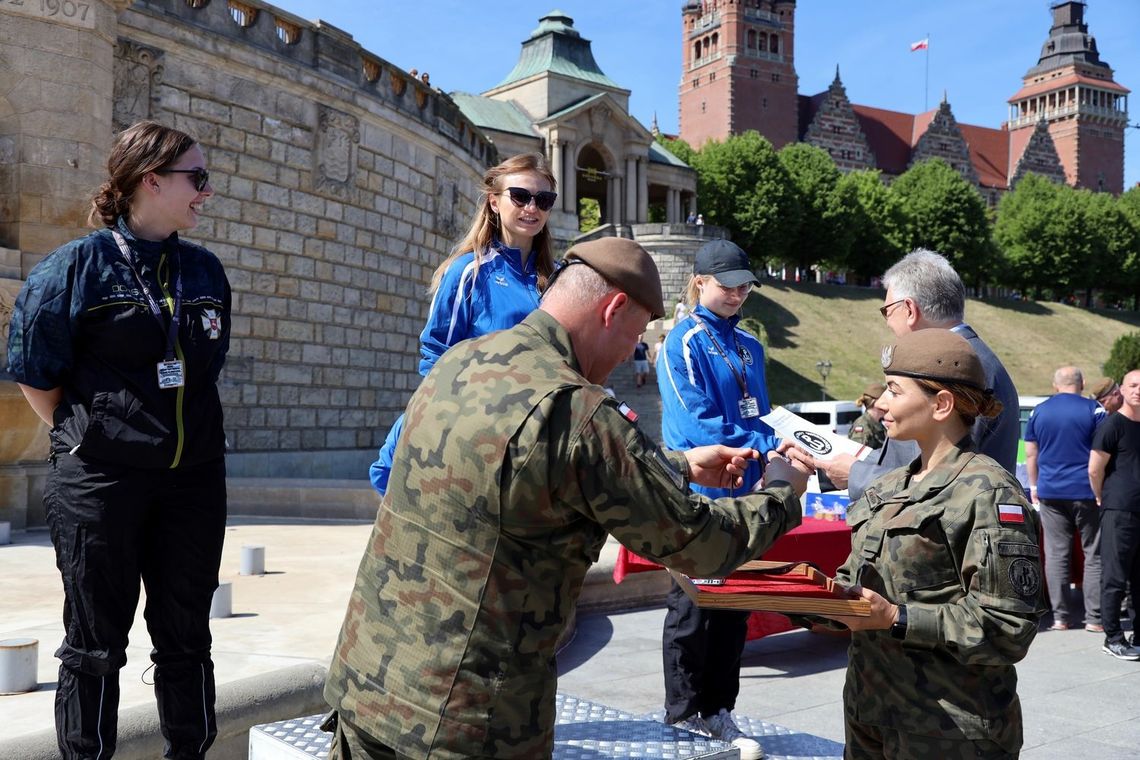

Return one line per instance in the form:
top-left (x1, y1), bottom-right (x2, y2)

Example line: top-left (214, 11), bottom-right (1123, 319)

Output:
top-left (893, 158), bottom-right (1000, 286)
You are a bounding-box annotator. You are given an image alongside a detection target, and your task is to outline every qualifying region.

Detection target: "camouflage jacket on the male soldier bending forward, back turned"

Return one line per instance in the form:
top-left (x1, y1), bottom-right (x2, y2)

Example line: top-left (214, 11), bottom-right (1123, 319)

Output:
top-left (325, 311), bottom-right (800, 759)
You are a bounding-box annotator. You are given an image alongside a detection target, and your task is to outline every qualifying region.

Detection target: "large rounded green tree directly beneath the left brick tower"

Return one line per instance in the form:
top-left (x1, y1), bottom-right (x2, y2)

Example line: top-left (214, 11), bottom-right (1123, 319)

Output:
top-left (691, 130), bottom-right (799, 263)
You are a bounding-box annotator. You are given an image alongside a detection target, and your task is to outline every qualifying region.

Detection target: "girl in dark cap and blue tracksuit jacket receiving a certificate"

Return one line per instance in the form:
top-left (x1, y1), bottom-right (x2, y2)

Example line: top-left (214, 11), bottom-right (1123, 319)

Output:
top-left (657, 240), bottom-right (779, 759)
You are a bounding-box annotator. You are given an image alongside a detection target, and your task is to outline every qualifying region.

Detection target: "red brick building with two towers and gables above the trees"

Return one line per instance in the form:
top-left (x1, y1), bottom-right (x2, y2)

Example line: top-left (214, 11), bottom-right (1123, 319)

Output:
top-left (679, 0), bottom-right (1129, 195)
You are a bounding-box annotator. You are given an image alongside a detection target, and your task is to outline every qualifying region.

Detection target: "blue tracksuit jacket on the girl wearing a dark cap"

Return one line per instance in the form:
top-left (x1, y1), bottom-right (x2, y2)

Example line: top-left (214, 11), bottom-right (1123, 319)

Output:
top-left (657, 305), bottom-right (779, 498)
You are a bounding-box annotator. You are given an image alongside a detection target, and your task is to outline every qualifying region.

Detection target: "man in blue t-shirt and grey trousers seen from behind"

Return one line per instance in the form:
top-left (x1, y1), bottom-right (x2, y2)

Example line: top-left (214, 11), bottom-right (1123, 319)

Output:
top-left (1025, 367), bottom-right (1106, 631)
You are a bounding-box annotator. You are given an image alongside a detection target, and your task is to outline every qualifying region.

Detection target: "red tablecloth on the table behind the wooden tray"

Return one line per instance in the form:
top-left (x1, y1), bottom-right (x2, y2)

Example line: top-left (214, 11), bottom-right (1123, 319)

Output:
top-left (613, 517), bottom-right (852, 639)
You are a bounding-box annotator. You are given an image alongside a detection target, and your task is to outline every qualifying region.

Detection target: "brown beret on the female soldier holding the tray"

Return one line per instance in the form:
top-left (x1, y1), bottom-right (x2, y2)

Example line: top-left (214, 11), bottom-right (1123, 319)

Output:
top-left (882, 328), bottom-right (987, 391)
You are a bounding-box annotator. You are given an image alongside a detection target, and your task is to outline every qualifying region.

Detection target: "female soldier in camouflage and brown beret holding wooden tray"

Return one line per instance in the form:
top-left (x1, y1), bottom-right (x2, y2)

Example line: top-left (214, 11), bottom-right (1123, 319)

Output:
top-left (816, 329), bottom-right (1044, 759)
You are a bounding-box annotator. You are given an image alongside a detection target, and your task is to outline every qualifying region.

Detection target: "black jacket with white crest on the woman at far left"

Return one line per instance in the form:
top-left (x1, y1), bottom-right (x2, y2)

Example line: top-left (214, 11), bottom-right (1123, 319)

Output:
top-left (8, 220), bottom-right (230, 468)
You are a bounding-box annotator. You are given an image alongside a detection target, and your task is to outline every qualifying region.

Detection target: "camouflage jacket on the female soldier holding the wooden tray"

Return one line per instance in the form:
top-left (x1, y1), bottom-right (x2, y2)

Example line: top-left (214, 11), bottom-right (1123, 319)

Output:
top-left (837, 440), bottom-right (1044, 752)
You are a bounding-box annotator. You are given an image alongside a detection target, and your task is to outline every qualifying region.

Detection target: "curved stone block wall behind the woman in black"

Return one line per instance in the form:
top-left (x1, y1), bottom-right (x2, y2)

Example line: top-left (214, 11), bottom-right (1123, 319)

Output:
top-left (107, 0), bottom-right (497, 476)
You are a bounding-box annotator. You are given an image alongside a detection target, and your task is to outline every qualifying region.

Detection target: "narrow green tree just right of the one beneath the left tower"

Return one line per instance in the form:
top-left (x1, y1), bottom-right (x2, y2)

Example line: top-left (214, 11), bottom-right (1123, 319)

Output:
top-left (777, 142), bottom-right (858, 269)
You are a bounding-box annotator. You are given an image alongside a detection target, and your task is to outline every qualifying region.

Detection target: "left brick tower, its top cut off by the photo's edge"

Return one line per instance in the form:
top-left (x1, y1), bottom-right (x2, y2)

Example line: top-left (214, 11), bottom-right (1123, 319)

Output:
top-left (681, 0), bottom-right (799, 149)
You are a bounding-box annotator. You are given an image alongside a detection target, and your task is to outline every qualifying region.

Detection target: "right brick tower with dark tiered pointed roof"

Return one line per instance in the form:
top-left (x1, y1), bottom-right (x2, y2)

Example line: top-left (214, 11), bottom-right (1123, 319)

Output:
top-left (1009, 0), bottom-right (1129, 194)
